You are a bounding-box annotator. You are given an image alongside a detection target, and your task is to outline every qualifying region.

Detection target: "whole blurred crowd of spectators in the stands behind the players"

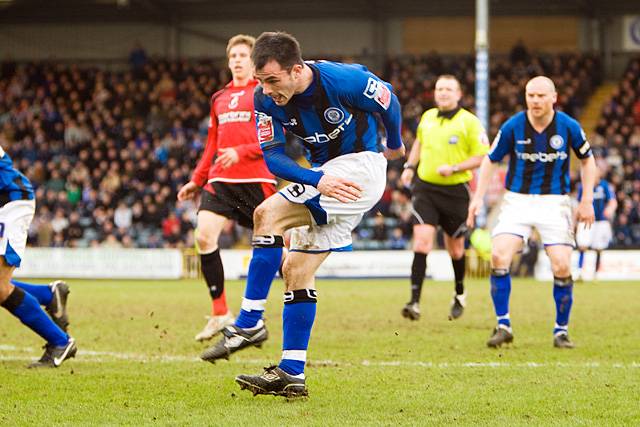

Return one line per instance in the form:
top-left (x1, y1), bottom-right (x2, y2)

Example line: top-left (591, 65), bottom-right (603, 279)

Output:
top-left (0, 47), bottom-right (640, 249)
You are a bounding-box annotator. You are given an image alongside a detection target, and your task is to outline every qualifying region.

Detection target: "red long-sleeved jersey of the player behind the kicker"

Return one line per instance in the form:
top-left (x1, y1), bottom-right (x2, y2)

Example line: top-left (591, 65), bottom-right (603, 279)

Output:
top-left (191, 80), bottom-right (276, 187)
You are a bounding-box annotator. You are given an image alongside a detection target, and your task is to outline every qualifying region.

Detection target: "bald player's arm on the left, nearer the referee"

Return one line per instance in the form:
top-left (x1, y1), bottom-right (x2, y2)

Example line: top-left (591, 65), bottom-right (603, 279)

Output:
top-left (467, 122), bottom-right (513, 228)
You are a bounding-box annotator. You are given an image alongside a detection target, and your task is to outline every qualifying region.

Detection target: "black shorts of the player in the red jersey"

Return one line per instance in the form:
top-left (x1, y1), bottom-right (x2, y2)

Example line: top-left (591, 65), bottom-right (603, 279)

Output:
top-left (199, 182), bottom-right (276, 228)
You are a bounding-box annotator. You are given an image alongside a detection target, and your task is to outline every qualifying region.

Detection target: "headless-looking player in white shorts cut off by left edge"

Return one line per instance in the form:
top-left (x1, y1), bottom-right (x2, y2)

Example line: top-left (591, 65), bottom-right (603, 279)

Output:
top-left (0, 148), bottom-right (77, 368)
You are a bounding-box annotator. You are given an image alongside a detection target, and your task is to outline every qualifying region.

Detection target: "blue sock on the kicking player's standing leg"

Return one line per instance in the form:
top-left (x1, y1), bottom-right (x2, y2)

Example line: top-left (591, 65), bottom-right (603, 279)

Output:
top-left (278, 289), bottom-right (317, 375)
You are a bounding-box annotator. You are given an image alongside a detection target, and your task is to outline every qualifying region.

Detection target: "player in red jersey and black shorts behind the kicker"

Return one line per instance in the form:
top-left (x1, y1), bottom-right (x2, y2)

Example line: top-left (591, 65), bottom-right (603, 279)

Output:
top-left (178, 34), bottom-right (276, 341)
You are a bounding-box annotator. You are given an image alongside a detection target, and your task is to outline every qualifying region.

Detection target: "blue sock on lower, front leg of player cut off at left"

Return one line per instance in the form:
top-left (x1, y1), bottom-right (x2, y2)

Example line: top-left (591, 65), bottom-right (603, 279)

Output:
top-left (2, 287), bottom-right (69, 347)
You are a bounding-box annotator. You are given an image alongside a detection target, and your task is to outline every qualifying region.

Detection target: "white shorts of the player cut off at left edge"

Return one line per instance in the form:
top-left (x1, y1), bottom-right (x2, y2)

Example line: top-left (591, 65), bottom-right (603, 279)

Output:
top-left (0, 200), bottom-right (36, 267)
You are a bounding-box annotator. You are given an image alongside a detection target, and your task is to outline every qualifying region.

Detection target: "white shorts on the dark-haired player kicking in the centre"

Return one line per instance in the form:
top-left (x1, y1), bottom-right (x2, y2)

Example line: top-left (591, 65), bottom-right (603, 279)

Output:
top-left (279, 151), bottom-right (387, 252)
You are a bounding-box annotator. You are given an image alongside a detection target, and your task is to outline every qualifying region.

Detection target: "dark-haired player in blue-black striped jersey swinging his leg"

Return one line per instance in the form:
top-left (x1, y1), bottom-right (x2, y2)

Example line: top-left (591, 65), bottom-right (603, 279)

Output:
top-left (202, 32), bottom-right (404, 396)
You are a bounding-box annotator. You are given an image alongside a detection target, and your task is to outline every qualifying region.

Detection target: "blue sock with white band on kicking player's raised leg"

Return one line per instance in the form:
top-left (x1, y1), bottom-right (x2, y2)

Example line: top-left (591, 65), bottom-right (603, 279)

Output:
top-left (235, 236), bottom-right (284, 329)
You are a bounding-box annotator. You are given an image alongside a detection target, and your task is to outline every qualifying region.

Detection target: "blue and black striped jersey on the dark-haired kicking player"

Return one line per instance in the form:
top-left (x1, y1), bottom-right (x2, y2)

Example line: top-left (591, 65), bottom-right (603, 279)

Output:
top-left (254, 61), bottom-right (402, 167)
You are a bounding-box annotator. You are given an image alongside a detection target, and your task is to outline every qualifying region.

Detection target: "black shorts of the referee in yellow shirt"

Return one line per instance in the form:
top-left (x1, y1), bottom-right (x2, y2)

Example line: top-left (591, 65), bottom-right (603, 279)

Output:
top-left (412, 178), bottom-right (469, 238)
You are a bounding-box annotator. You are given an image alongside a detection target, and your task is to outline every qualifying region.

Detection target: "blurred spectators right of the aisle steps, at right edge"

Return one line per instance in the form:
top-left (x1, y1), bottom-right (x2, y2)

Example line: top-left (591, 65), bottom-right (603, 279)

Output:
top-left (592, 58), bottom-right (640, 247)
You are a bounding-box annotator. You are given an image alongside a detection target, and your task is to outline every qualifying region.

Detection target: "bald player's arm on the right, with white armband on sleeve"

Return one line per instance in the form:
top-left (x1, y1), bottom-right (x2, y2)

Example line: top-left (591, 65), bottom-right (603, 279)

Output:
top-left (570, 123), bottom-right (597, 227)
